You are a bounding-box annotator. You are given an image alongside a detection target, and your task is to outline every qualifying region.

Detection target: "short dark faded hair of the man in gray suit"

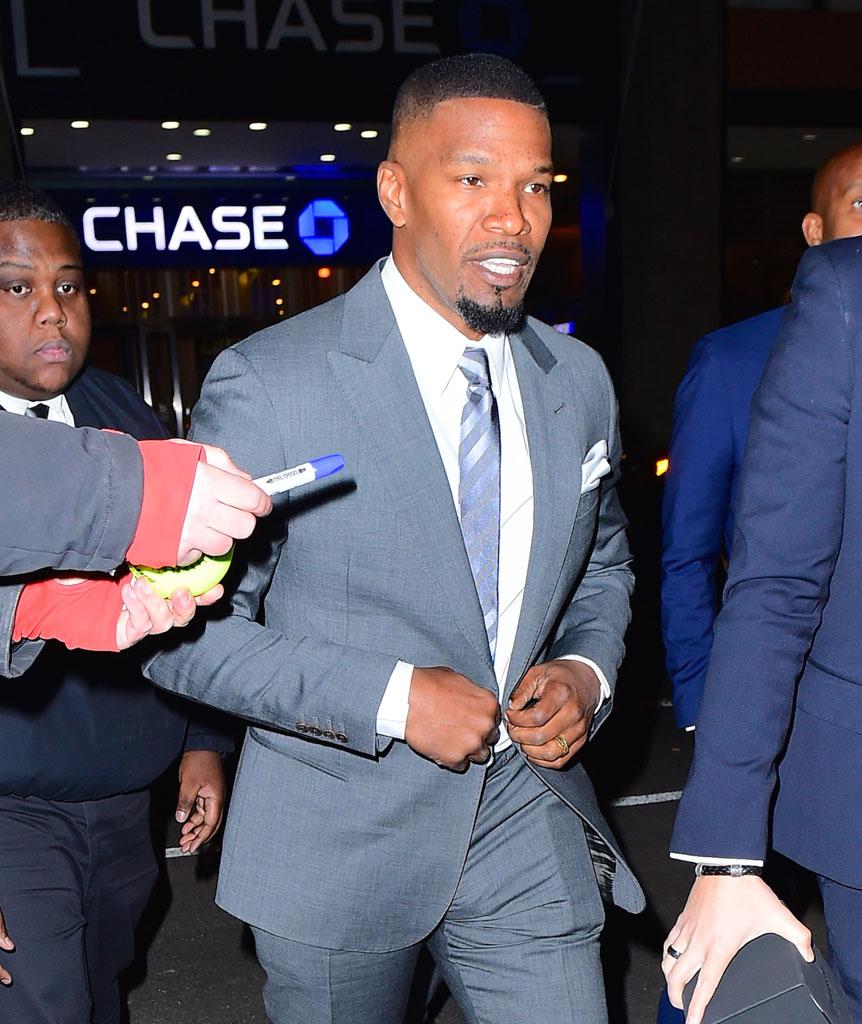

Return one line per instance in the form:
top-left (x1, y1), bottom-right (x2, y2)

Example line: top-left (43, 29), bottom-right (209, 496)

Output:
top-left (392, 53), bottom-right (548, 149)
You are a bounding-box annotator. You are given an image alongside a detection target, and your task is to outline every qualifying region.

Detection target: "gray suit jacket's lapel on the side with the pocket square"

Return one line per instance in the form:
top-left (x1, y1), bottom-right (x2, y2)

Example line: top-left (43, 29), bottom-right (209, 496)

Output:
top-left (505, 327), bottom-right (587, 699)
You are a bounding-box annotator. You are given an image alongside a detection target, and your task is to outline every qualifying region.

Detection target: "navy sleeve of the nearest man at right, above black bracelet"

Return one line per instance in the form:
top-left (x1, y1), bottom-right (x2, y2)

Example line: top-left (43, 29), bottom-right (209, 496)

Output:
top-left (672, 243), bottom-right (853, 859)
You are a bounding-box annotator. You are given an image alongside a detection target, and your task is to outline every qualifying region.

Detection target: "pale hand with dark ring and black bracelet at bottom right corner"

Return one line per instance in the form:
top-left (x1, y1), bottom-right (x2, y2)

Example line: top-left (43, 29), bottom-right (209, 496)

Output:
top-left (661, 874), bottom-right (814, 1024)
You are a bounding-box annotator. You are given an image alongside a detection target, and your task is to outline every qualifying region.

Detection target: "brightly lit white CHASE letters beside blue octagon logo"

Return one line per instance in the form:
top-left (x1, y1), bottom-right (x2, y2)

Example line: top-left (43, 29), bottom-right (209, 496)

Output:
top-left (82, 205), bottom-right (290, 253)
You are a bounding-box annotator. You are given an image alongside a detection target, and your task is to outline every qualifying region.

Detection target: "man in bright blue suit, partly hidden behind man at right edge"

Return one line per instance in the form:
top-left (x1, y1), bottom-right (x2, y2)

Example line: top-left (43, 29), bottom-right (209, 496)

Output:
top-left (661, 143), bottom-right (862, 729)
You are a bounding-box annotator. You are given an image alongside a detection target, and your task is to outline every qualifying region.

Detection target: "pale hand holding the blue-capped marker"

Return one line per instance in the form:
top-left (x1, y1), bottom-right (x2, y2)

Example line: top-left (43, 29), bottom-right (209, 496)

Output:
top-left (177, 444), bottom-right (272, 565)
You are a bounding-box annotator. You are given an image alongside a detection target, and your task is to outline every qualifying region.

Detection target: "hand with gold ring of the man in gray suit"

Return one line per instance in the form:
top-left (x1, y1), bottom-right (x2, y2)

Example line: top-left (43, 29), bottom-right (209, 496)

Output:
top-left (506, 659), bottom-right (602, 768)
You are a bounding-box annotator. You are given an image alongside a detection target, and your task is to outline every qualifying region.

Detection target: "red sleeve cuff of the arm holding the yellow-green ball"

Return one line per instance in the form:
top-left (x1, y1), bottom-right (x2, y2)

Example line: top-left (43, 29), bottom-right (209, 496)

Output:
top-left (12, 573), bottom-right (131, 651)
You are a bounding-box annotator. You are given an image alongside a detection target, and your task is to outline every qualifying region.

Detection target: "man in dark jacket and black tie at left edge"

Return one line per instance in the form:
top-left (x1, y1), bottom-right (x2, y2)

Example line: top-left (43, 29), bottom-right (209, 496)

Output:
top-left (0, 184), bottom-right (230, 1024)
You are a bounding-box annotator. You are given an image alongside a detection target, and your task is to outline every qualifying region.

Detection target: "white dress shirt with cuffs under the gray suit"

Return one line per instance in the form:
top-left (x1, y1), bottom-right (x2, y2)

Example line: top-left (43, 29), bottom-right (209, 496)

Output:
top-left (377, 256), bottom-right (610, 751)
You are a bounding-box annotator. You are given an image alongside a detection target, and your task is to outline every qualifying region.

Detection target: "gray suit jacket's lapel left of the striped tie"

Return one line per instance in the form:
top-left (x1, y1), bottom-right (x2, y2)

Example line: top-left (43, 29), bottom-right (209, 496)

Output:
top-left (329, 268), bottom-right (493, 686)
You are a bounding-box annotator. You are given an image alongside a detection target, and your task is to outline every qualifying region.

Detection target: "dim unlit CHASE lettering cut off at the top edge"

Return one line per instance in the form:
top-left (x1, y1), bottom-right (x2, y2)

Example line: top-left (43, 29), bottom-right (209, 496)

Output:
top-left (140, 0), bottom-right (440, 53)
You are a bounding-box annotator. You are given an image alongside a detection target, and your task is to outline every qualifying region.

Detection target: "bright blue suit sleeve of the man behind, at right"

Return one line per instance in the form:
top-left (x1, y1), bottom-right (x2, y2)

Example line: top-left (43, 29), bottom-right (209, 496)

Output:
top-left (661, 336), bottom-right (734, 728)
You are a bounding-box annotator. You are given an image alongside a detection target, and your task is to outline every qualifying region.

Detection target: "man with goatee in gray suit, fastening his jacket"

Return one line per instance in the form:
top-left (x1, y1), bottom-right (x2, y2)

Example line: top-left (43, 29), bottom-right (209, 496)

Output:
top-left (149, 54), bottom-right (643, 1024)
